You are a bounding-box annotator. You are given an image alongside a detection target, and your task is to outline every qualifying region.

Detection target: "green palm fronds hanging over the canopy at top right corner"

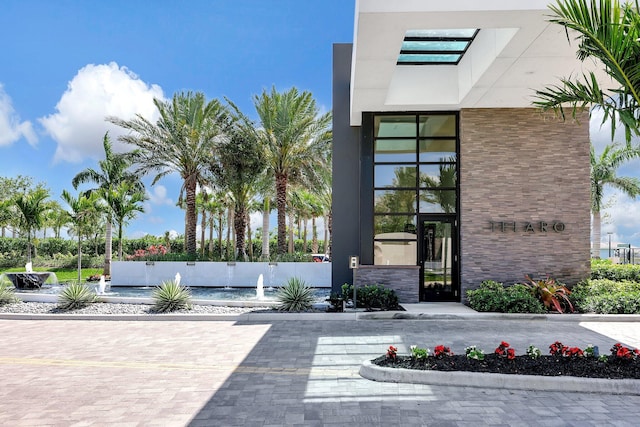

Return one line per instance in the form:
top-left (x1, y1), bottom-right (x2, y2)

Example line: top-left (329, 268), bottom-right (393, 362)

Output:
top-left (534, 0), bottom-right (640, 142)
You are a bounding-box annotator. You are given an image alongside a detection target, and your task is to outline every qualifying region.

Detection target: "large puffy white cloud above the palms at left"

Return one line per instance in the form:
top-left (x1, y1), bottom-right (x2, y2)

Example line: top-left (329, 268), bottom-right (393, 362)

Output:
top-left (38, 62), bottom-right (164, 163)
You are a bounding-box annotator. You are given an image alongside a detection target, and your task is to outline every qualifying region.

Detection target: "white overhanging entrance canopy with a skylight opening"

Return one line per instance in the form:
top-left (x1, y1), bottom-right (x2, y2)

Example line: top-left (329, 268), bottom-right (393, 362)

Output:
top-left (350, 0), bottom-right (606, 126)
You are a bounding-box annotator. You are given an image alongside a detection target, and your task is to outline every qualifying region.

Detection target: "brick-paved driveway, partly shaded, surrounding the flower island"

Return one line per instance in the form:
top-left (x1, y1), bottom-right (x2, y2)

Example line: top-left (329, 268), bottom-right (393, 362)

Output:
top-left (0, 309), bottom-right (640, 426)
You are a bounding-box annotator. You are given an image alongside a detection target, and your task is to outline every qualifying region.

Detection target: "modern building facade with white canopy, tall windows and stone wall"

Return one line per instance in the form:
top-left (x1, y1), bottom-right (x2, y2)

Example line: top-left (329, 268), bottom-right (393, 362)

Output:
top-left (332, 0), bottom-right (604, 303)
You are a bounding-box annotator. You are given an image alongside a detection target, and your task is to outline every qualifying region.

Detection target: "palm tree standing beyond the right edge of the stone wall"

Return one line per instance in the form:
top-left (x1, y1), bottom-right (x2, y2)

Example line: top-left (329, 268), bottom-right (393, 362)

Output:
top-left (591, 144), bottom-right (640, 257)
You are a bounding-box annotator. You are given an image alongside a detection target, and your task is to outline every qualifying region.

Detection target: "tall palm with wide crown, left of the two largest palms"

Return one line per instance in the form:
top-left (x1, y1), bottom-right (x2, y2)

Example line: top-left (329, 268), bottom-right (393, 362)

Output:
top-left (108, 92), bottom-right (228, 257)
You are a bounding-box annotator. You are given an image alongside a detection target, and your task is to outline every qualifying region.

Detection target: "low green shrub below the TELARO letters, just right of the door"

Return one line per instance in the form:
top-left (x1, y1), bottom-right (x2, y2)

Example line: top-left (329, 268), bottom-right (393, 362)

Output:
top-left (466, 280), bottom-right (546, 313)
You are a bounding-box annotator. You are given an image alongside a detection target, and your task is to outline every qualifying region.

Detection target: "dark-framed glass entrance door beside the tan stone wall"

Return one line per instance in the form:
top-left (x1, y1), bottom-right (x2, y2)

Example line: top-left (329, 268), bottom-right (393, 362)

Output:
top-left (419, 215), bottom-right (460, 301)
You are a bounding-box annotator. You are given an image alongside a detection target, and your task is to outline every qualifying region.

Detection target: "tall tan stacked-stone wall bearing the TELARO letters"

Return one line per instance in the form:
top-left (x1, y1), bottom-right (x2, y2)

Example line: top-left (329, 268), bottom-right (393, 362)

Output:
top-left (460, 109), bottom-right (590, 299)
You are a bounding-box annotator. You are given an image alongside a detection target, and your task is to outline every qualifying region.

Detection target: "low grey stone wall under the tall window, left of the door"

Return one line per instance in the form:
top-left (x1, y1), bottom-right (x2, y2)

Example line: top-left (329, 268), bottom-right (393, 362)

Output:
top-left (356, 265), bottom-right (420, 304)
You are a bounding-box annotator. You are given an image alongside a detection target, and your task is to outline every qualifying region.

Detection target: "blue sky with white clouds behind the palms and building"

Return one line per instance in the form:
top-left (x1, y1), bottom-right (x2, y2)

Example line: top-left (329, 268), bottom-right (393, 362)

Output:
top-left (0, 0), bottom-right (640, 246)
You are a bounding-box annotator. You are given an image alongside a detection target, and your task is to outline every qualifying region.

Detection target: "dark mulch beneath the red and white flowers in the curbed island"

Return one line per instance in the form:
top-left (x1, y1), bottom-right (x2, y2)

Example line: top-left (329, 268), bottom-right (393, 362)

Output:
top-left (371, 354), bottom-right (640, 379)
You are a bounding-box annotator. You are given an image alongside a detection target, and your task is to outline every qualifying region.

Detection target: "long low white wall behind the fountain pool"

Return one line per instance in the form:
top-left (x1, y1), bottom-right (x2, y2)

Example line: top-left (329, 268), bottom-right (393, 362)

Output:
top-left (111, 261), bottom-right (331, 288)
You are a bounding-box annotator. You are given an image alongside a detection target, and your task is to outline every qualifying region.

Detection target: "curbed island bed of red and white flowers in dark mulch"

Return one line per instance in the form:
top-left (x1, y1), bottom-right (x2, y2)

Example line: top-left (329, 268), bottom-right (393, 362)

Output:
top-left (371, 341), bottom-right (640, 379)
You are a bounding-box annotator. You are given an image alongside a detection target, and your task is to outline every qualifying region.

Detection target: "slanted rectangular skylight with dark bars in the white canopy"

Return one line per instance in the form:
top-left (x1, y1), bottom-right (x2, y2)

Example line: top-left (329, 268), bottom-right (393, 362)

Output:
top-left (398, 28), bottom-right (480, 65)
